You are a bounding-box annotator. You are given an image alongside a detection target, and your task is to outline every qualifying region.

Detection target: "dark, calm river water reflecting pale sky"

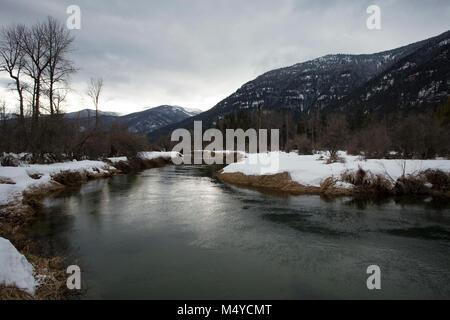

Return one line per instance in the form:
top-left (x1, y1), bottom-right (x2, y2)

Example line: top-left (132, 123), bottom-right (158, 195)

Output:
top-left (25, 166), bottom-right (450, 299)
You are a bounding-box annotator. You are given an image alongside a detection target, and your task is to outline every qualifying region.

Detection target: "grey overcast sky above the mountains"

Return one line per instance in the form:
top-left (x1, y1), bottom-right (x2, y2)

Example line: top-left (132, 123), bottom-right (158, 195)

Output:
top-left (0, 0), bottom-right (450, 113)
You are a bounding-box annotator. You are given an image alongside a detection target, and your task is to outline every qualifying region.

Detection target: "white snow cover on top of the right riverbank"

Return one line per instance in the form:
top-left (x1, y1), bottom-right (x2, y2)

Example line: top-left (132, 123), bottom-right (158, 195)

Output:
top-left (223, 152), bottom-right (450, 187)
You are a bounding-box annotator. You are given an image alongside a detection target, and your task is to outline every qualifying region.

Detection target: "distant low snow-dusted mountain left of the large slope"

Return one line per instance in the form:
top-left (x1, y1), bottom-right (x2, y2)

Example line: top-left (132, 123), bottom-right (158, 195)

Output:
top-left (64, 105), bottom-right (201, 134)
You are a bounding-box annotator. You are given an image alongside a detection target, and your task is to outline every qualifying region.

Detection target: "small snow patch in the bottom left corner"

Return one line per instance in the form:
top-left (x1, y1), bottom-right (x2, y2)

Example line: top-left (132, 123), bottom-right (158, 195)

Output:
top-left (0, 237), bottom-right (36, 295)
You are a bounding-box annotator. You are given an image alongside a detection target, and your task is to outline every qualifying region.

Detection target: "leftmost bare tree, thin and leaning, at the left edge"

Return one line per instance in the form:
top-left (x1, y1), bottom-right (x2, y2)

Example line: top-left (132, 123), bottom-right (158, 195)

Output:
top-left (0, 25), bottom-right (25, 126)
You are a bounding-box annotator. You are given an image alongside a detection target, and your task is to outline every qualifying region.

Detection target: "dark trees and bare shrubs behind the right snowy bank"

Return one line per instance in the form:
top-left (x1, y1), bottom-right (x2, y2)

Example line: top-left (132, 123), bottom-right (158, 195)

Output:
top-left (215, 97), bottom-right (450, 159)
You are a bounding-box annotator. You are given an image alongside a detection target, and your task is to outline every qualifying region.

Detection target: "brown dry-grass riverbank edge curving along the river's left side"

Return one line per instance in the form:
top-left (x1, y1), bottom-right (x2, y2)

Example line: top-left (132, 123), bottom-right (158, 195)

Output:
top-left (0, 156), bottom-right (173, 300)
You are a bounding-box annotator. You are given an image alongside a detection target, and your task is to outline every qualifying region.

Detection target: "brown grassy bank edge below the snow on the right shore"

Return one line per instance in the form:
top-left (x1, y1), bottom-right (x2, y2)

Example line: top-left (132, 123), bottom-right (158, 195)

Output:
top-left (216, 169), bottom-right (450, 200)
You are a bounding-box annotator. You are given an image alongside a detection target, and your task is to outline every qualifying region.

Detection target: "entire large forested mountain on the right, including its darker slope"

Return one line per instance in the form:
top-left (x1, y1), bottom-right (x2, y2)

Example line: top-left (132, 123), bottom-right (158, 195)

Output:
top-left (153, 31), bottom-right (450, 136)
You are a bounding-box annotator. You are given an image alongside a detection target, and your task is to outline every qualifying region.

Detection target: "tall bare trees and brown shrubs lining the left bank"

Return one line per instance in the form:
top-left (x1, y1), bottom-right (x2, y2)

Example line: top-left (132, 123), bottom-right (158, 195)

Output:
top-left (0, 17), bottom-right (147, 162)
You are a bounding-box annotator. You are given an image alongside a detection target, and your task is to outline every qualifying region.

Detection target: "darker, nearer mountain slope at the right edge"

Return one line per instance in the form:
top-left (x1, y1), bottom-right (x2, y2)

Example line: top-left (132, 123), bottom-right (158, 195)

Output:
top-left (330, 32), bottom-right (450, 113)
